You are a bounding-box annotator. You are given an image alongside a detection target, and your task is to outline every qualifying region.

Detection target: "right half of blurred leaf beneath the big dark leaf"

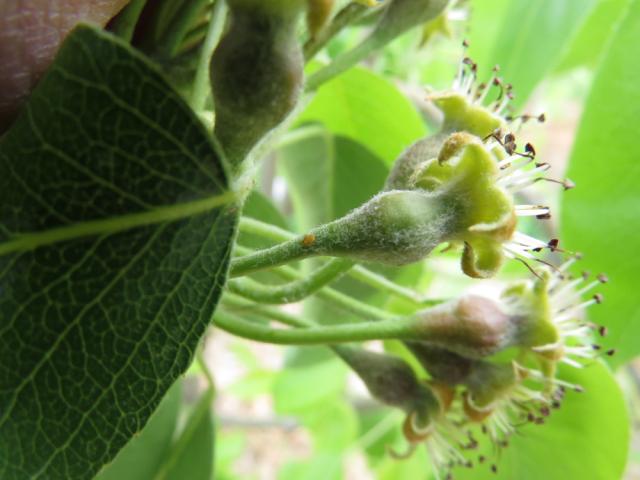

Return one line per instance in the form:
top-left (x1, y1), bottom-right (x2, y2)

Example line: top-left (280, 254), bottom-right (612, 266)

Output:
top-left (153, 389), bottom-right (214, 480)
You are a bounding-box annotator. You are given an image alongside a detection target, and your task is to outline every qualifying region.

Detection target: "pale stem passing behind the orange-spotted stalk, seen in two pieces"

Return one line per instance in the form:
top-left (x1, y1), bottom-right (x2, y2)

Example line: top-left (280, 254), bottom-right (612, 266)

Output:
top-left (240, 217), bottom-right (428, 306)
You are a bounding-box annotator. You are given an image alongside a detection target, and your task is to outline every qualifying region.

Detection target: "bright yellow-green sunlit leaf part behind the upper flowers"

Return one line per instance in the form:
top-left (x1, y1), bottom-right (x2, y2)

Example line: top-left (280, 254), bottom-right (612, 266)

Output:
top-left (298, 68), bottom-right (426, 165)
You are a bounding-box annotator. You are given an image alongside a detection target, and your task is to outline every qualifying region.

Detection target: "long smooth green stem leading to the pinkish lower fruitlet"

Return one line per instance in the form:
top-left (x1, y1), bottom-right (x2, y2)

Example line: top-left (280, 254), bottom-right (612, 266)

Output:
top-left (213, 310), bottom-right (423, 345)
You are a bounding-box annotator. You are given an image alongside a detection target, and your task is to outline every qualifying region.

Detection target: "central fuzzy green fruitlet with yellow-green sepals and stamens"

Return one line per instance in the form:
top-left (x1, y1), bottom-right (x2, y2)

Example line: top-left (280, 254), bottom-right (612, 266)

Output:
top-left (282, 132), bottom-right (552, 278)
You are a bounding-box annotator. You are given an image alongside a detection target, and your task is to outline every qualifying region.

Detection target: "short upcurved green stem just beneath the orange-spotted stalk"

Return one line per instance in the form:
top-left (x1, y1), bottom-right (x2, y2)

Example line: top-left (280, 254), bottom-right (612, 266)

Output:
top-left (227, 259), bottom-right (353, 304)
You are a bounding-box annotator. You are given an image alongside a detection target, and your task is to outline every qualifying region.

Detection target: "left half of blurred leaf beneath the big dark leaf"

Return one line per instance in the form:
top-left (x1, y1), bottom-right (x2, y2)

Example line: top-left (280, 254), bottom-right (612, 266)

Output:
top-left (96, 381), bottom-right (182, 480)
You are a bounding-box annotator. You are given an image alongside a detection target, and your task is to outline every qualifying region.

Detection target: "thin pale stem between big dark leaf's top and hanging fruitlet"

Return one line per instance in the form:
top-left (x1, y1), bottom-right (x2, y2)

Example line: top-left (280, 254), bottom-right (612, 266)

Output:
top-left (191, 0), bottom-right (227, 112)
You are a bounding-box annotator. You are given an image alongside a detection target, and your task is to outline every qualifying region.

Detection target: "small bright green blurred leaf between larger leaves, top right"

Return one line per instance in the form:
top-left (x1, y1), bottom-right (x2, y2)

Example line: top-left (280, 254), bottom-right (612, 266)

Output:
top-left (557, 0), bottom-right (629, 72)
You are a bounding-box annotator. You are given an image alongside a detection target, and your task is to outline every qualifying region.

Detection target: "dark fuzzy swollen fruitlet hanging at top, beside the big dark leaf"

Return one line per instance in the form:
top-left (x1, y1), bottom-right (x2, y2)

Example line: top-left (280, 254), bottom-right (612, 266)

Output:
top-left (210, 0), bottom-right (304, 167)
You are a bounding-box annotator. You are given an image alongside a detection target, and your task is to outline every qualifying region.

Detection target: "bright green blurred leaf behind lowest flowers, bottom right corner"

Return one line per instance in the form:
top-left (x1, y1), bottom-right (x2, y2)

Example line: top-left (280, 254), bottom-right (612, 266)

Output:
top-left (454, 362), bottom-right (629, 480)
